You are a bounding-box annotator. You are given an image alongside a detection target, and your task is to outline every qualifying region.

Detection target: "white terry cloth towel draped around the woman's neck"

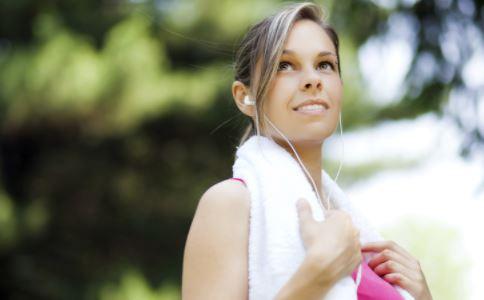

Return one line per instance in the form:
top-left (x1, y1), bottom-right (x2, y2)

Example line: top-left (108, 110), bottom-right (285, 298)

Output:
top-left (233, 136), bottom-right (413, 300)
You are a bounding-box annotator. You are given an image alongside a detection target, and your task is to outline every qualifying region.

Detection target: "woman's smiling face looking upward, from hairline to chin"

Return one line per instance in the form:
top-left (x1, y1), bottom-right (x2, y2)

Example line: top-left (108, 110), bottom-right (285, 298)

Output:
top-left (261, 20), bottom-right (343, 145)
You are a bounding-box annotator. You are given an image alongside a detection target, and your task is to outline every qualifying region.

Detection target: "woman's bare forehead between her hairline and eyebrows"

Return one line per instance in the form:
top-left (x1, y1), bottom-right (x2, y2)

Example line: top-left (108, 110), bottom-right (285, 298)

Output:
top-left (284, 19), bottom-right (336, 54)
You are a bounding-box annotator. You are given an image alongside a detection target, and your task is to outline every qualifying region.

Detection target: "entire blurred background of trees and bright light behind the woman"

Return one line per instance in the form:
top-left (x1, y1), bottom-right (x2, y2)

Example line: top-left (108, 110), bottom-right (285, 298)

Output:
top-left (0, 0), bottom-right (484, 300)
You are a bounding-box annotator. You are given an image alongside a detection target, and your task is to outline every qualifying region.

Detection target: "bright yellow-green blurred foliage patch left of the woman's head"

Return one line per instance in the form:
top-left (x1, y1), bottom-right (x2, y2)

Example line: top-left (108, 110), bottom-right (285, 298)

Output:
top-left (0, 10), bottom-right (229, 135)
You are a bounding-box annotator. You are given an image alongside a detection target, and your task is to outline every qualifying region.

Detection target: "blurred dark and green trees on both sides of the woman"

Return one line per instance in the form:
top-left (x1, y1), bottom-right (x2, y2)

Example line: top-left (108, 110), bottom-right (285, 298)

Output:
top-left (0, 0), bottom-right (483, 299)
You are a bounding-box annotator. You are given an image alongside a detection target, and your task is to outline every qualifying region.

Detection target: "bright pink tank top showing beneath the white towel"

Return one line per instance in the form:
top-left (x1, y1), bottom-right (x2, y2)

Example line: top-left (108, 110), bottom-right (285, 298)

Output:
top-left (230, 177), bottom-right (403, 300)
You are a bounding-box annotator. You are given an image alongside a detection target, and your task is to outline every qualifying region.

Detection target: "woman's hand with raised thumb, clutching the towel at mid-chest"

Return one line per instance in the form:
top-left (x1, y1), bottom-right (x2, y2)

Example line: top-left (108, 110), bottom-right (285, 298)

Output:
top-left (297, 199), bottom-right (362, 285)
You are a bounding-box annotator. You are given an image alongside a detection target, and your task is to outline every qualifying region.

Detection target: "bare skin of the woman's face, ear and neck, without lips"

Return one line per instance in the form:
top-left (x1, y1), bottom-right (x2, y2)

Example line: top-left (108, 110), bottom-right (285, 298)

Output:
top-left (232, 20), bottom-right (343, 204)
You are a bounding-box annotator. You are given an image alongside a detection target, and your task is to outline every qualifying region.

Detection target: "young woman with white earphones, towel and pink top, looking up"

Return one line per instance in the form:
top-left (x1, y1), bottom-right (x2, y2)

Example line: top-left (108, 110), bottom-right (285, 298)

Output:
top-left (182, 3), bottom-right (432, 300)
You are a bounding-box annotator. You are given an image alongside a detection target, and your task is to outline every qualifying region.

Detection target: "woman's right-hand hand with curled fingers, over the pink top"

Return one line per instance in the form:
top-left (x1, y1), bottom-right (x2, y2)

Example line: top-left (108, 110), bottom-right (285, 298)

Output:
top-left (361, 241), bottom-right (432, 300)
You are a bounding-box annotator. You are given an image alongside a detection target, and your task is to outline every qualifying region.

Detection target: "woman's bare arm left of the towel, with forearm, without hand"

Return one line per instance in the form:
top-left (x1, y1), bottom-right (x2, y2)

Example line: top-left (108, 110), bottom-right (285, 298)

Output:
top-left (182, 180), bottom-right (332, 300)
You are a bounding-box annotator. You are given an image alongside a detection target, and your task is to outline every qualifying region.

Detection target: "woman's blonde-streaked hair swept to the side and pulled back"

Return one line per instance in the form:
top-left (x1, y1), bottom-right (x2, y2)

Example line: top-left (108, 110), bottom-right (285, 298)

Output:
top-left (234, 2), bottom-right (341, 145)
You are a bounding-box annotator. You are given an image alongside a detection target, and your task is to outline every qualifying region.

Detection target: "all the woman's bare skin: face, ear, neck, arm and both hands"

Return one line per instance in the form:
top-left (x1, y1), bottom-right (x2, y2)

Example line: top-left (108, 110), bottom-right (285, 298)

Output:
top-left (182, 20), bottom-right (431, 300)
